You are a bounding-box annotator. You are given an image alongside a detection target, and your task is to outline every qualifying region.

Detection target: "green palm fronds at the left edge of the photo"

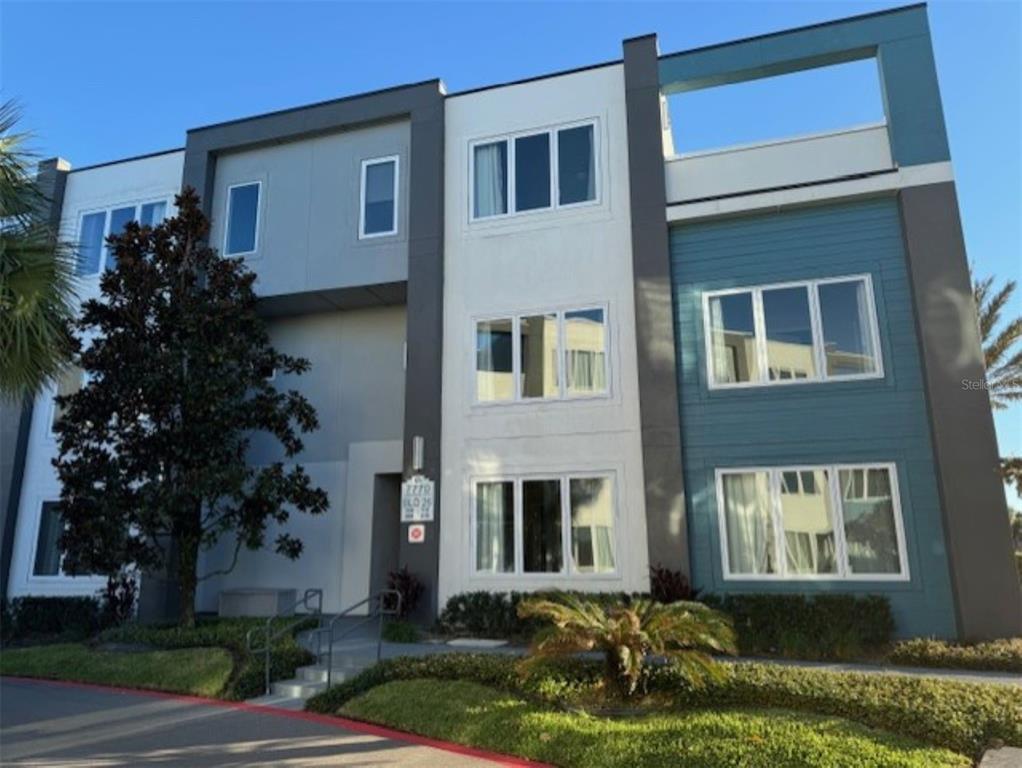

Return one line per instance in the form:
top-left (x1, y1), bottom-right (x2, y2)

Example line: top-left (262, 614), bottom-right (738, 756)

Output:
top-left (0, 101), bottom-right (77, 400)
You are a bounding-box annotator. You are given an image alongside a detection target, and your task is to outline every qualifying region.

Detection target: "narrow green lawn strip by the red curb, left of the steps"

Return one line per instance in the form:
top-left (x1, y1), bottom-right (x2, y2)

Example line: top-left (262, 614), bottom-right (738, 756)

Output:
top-left (0, 643), bottom-right (233, 696)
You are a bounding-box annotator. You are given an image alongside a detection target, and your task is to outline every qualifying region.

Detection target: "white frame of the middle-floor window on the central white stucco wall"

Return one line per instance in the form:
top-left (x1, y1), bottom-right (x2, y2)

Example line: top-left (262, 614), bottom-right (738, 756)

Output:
top-left (468, 302), bottom-right (613, 408)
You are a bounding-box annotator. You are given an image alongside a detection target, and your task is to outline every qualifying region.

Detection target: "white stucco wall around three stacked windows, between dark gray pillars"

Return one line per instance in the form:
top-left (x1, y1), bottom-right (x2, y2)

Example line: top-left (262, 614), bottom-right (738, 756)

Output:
top-left (438, 64), bottom-right (649, 605)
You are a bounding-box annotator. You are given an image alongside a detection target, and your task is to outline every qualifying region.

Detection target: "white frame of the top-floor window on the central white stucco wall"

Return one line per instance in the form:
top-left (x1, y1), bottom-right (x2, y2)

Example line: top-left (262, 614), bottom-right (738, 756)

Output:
top-left (468, 118), bottom-right (603, 224)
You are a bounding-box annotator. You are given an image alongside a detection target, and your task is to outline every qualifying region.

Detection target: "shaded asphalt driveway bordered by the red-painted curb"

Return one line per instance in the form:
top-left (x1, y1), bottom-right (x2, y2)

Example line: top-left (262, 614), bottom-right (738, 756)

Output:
top-left (0, 678), bottom-right (513, 768)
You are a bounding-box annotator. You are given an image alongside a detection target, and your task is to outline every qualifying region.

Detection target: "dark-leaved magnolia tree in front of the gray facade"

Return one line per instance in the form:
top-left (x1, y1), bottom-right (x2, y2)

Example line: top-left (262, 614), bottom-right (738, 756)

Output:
top-left (54, 189), bottom-right (327, 626)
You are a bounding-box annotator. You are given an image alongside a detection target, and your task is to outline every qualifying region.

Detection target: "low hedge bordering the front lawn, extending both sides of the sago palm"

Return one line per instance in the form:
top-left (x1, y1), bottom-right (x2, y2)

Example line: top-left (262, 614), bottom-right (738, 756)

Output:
top-left (306, 653), bottom-right (1022, 756)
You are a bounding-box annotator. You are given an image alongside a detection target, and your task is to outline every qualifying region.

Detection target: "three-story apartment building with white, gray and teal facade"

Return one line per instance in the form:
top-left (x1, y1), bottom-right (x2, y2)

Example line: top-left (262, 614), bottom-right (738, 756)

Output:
top-left (0, 6), bottom-right (1022, 638)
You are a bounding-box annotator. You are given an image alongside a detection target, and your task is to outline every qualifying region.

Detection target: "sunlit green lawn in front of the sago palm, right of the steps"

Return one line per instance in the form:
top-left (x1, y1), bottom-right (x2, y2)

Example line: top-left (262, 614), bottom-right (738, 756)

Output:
top-left (340, 679), bottom-right (972, 768)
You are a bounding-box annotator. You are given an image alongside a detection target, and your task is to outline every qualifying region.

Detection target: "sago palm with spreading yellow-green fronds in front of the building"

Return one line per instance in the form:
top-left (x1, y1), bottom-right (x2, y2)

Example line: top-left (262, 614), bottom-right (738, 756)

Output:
top-left (518, 594), bottom-right (736, 696)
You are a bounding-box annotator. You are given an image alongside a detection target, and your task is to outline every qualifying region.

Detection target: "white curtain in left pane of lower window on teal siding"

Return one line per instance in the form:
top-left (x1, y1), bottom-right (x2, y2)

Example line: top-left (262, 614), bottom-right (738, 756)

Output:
top-left (723, 472), bottom-right (774, 574)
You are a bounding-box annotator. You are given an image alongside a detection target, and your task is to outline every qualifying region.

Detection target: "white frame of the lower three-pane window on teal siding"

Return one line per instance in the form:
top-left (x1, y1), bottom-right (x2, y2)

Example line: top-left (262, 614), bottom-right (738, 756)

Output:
top-left (713, 461), bottom-right (911, 583)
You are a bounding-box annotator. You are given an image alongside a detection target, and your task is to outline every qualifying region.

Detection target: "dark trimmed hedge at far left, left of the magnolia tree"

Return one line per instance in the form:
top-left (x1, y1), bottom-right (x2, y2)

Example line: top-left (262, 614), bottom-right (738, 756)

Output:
top-left (3, 597), bottom-right (101, 642)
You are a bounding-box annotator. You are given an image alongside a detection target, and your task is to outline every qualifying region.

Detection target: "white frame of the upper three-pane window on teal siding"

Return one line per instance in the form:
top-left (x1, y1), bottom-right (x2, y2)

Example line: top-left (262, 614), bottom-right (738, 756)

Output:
top-left (702, 273), bottom-right (884, 390)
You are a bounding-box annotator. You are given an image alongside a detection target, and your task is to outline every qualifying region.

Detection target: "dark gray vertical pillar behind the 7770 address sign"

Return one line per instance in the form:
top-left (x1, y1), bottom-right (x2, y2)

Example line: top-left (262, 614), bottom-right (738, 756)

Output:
top-left (401, 97), bottom-right (444, 621)
